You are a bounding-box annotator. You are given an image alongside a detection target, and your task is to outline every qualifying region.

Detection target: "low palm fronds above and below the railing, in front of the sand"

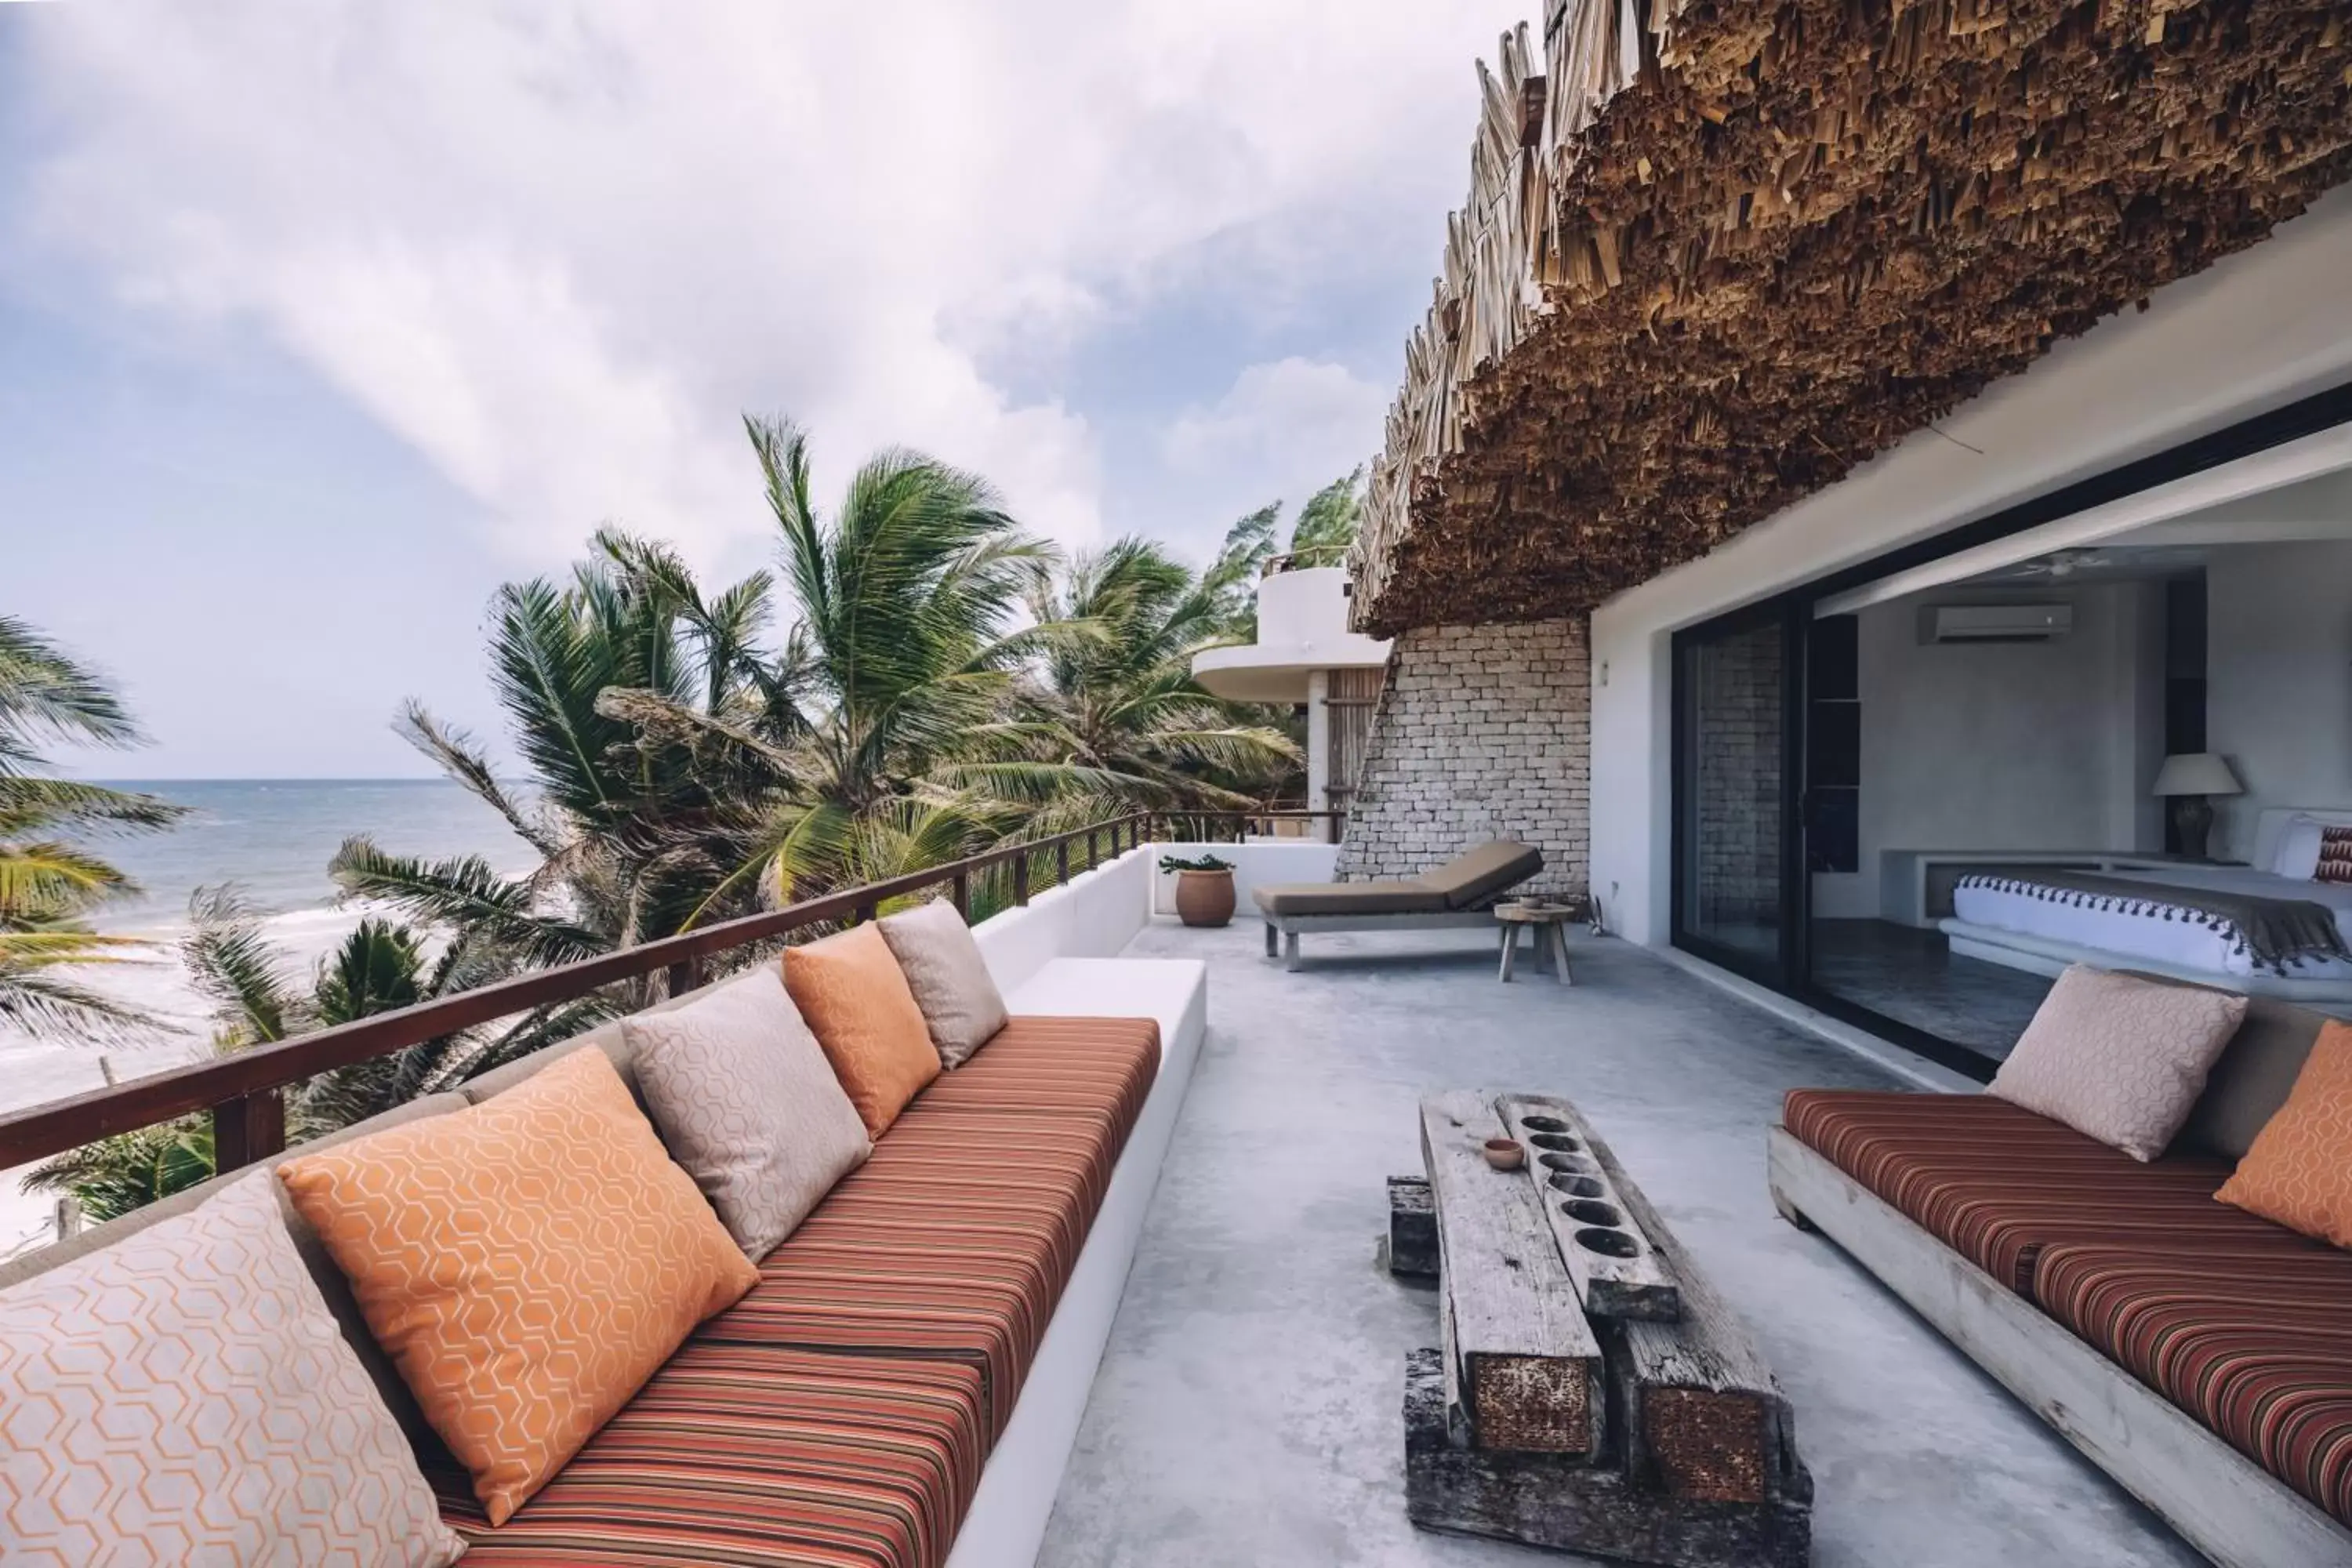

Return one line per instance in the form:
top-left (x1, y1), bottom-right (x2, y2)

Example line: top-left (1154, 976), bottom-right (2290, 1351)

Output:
top-left (24, 886), bottom-right (614, 1220)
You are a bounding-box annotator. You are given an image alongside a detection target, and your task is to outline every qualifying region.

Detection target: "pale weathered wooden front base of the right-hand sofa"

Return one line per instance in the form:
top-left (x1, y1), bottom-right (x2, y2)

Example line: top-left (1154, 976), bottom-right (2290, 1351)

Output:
top-left (1766, 1126), bottom-right (2352, 1568)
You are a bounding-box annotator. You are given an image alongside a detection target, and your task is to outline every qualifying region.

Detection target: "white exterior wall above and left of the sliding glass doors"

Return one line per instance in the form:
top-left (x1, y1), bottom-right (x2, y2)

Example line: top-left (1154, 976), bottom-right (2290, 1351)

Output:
top-left (1592, 191), bottom-right (2352, 942)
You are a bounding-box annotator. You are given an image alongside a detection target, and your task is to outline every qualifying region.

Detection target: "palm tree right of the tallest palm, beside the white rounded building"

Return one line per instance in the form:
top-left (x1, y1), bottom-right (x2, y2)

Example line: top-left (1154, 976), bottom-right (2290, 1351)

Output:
top-left (978, 539), bottom-right (1298, 827)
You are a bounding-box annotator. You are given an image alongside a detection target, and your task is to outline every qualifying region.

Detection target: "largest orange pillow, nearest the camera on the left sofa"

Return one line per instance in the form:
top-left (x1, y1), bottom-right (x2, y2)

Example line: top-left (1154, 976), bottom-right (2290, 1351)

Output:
top-left (278, 1048), bottom-right (760, 1526)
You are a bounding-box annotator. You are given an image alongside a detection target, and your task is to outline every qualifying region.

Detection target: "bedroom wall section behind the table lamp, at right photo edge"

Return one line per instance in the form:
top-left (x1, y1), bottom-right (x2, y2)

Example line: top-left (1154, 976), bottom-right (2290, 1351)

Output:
top-left (2206, 543), bottom-right (2352, 860)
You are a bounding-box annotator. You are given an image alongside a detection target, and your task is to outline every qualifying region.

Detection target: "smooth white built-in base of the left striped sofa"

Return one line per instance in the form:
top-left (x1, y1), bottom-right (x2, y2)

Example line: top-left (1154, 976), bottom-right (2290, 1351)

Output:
top-left (948, 959), bottom-right (1209, 1568)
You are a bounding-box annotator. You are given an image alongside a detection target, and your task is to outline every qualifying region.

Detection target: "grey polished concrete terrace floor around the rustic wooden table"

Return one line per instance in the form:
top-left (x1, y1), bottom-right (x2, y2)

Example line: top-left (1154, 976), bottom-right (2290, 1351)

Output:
top-left (1037, 921), bottom-right (2201, 1568)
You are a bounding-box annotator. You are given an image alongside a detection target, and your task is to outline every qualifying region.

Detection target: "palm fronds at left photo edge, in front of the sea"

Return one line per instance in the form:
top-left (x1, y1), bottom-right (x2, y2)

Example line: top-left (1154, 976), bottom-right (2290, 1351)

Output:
top-left (0, 616), bottom-right (181, 1039)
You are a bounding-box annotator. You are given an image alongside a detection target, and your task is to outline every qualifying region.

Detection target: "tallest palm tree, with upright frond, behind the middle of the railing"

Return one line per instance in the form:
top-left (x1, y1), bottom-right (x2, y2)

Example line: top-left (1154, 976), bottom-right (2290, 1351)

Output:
top-left (602, 419), bottom-right (1070, 919)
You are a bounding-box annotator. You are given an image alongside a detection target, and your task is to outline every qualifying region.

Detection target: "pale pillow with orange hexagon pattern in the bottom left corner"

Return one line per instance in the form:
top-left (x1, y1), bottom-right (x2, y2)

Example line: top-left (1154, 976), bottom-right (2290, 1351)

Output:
top-left (0, 1173), bottom-right (466, 1568)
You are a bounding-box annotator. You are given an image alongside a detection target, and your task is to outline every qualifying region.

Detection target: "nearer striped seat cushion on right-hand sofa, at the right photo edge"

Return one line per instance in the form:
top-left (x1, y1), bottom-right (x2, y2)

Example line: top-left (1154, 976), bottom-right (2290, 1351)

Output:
top-left (2034, 1232), bottom-right (2352, 1523)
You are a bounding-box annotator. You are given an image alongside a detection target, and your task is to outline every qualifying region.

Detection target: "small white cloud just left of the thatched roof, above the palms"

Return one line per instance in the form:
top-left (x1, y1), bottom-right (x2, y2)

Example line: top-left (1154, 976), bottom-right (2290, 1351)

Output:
top-left (1162, 358), bottom-right (1392, 531)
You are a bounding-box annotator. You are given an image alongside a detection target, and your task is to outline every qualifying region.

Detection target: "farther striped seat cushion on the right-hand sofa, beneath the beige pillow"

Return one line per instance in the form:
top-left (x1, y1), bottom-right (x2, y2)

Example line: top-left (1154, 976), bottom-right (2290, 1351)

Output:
top-left (1783, 1088), bottom-right (2239, 1295)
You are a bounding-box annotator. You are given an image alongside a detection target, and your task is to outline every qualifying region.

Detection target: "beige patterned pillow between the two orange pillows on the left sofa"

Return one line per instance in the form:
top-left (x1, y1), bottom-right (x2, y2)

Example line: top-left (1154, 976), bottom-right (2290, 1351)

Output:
top-left (621, 964), bottom-right (873, 1260)
